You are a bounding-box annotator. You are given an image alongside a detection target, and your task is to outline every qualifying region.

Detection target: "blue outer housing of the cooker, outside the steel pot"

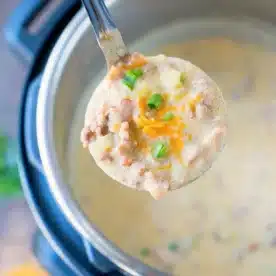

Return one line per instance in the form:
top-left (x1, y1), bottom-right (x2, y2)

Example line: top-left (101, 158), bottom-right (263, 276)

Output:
top-left (5, 0), bottom-right (123, 276)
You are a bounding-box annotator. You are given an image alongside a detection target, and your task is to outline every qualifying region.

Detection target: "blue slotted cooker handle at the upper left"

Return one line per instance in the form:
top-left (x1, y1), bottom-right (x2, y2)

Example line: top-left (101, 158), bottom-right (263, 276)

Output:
top-left (4, 0), bottom-right (80, 63)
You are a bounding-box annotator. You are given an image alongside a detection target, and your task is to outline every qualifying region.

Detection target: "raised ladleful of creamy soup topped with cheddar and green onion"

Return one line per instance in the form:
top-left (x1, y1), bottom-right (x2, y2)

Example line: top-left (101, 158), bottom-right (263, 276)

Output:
top-left (81, 53), bottom-right (227, 199)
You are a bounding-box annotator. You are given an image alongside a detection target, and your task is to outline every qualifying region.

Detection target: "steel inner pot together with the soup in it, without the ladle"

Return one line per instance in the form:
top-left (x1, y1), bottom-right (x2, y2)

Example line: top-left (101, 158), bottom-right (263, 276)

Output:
top-left (16, 0), bottom-right (276, 276)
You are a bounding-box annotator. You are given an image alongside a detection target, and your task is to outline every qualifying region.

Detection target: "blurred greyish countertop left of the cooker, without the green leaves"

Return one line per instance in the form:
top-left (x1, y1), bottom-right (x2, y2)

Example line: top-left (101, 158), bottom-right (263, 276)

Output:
top-left (0, 0), bottom-right (40, 275)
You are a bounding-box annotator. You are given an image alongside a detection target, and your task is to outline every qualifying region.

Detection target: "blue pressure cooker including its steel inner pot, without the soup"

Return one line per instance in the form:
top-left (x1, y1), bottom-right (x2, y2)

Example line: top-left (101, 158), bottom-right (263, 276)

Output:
top-left (6, 0), bottom-right (276, 275)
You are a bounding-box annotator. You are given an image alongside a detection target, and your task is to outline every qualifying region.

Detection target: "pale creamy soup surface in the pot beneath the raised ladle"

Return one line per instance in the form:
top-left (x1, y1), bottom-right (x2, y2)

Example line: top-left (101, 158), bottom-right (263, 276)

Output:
top-left (68, 18), bottom-right (276, 276)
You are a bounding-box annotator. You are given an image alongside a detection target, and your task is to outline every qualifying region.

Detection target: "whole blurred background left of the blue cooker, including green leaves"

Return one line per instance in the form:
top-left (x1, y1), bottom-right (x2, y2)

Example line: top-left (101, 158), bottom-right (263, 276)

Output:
top-left (0, 0), bottom-right (44, 276)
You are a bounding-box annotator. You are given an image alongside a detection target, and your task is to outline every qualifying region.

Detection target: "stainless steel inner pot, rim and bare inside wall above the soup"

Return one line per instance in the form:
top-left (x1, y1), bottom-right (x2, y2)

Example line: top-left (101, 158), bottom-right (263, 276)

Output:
top-left (37, 0), bottom-right (276, 275)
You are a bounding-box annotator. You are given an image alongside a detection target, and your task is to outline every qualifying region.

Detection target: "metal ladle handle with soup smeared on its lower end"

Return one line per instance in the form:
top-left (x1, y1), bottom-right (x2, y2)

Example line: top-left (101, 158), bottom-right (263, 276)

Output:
top-left (82, 0), bottom-right (129, 68)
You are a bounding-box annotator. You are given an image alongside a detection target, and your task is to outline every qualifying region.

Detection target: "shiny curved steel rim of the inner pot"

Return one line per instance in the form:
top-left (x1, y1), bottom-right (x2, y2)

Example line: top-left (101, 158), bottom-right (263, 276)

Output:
top-left (36, 4), bottom-right (163, 275)
